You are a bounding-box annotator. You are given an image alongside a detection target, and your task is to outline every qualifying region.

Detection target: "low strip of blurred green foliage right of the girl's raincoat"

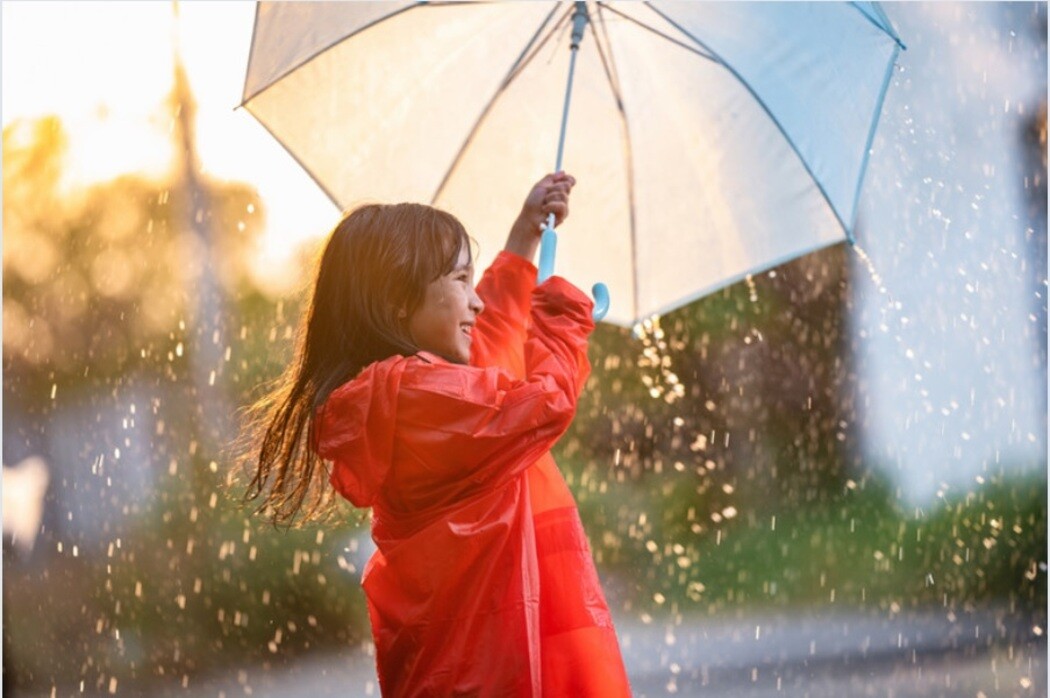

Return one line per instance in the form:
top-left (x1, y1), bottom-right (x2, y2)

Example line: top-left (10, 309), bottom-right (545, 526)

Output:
top-left (570, 447), bottom-right (1047, 616)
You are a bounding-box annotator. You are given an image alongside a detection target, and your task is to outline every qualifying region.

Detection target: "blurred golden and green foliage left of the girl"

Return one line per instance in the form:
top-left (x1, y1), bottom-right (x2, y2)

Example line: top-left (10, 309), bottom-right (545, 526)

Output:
top-left (3, 119), bottom-right (368, 693)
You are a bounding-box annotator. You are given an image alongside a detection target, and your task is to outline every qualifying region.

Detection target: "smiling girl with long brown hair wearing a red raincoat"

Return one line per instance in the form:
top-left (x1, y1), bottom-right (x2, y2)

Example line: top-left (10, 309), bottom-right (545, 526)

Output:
top-left (241, 173), bottom-right (630, 698)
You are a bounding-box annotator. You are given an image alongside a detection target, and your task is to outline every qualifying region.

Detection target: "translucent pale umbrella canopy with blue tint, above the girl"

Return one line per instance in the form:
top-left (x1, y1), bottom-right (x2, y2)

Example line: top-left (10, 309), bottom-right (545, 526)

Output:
top-left (243, 1), bottom-right (902, 325)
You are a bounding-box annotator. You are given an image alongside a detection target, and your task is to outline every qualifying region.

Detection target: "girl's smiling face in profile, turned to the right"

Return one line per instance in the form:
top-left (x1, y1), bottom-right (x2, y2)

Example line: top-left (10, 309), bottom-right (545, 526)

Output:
top-left (408, 245), bottom-right (485, 363)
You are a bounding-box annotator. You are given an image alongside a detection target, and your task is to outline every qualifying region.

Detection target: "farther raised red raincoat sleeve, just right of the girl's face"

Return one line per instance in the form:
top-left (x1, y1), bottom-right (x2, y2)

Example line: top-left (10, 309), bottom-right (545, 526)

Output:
top-left (470, 251), bottom-right (537, 378)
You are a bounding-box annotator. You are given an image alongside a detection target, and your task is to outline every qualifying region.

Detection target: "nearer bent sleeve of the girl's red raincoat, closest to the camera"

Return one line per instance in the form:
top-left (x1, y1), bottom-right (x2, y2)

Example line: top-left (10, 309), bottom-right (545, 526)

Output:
top-left (398, 277), bottom-right (594, 499)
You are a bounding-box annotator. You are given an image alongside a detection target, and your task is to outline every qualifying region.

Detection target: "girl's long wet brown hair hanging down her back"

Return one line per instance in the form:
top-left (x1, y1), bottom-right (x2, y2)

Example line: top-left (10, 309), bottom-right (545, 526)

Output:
top-left (237, 204), bottom-right (469, 526)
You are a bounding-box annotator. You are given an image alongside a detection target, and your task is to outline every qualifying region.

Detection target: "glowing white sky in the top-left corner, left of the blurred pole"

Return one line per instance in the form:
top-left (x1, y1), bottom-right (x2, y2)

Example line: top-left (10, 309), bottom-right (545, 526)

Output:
top-left (3, 3), bottom-right (172, 184)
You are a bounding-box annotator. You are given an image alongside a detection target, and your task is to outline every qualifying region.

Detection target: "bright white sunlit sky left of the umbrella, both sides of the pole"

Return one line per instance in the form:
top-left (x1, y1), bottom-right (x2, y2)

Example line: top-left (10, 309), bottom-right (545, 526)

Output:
top-left (2, 2), bottom-right (338, 292)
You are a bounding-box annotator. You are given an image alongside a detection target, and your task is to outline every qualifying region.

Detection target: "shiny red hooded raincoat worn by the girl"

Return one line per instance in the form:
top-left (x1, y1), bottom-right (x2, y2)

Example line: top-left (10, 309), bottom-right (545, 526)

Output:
top-left (317, 252), bottom-right (630, 698)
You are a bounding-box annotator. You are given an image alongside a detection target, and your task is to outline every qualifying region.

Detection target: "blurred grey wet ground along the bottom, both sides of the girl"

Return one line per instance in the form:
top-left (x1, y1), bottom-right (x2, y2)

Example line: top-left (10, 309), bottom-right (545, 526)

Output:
top-left (67, 611), bottom-right (1047, 698)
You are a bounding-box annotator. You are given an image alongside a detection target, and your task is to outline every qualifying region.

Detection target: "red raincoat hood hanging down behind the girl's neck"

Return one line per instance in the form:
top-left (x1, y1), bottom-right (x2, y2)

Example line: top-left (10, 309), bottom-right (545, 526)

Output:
top-left (315, 356), bottom-right (408, 508)
